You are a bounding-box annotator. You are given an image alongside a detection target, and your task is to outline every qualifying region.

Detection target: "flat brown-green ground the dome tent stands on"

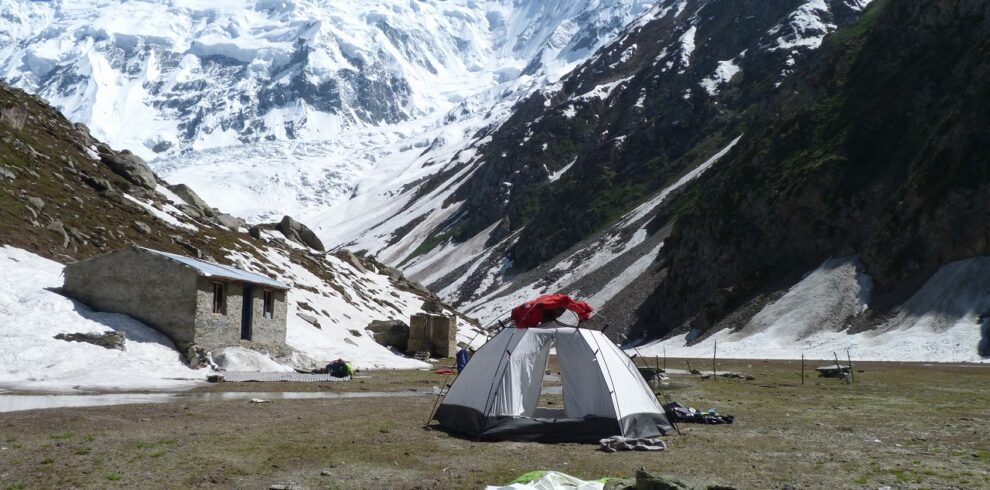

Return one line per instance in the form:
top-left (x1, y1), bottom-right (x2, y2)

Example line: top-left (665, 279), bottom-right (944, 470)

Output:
top-left (0, 360), bottom-right (990, 489)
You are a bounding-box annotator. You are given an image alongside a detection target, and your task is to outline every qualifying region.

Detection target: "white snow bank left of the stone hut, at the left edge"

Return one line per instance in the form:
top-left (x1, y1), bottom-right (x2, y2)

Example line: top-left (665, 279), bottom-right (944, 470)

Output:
top-left (0, 246), bottom-right (207, 391)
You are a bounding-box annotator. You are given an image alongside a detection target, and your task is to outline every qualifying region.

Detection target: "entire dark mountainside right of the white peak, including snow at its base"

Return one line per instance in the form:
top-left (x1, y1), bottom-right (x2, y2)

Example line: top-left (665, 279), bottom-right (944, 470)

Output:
top-left (324, 0), bottom-right (990, 361)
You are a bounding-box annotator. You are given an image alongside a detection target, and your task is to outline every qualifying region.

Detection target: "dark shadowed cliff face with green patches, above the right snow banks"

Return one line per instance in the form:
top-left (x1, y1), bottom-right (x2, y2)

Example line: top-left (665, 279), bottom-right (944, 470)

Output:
top-left (639, 0), bottom-right (990, 337)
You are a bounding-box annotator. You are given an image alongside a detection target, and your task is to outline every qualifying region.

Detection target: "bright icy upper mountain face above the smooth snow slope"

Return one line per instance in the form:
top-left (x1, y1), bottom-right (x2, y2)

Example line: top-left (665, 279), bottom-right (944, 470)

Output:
top-left (0, 0), bottom-right (649, 158)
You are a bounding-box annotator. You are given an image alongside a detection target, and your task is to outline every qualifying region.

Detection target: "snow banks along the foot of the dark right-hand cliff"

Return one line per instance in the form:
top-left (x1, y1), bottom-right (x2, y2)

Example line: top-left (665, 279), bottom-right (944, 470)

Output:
top-left (627, 257), bottom-right (990, 363)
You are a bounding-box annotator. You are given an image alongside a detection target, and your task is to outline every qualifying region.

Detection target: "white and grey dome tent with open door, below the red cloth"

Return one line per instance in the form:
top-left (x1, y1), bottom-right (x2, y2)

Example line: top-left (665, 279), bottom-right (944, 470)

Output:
top-left (434, 322), bottom-right (671, 442)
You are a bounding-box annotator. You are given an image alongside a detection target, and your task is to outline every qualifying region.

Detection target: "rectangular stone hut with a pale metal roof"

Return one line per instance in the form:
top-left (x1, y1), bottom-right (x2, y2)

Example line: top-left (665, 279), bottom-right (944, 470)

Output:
top-left (63, 247), bottom-right (289, 353)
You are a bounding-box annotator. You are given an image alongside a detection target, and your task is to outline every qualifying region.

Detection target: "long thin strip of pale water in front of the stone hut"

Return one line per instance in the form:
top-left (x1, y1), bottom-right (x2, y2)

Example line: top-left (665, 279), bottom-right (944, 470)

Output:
top-left (0, 391), bottom-right (433, 412)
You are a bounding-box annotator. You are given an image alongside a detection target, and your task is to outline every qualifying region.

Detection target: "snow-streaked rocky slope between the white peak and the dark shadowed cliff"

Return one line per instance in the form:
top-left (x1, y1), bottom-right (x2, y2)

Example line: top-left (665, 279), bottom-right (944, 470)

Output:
top-left (357, 1), bottom-right (865, 324)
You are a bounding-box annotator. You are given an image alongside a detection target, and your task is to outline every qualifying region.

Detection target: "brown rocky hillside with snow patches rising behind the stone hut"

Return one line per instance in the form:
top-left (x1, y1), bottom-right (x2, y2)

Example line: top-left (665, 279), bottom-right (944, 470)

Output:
top-left (0, 84), bottom-right (470, 367)
